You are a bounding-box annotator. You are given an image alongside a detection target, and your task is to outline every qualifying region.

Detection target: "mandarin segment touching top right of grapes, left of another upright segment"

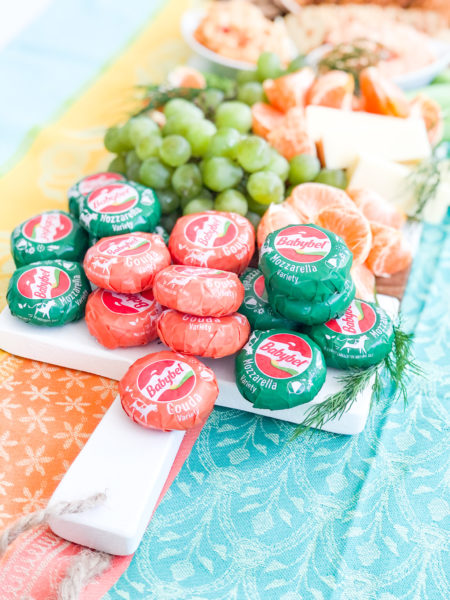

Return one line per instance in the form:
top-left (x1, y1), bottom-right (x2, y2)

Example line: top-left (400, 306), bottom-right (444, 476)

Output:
top-left (263, 67), bottom-right (314, 112)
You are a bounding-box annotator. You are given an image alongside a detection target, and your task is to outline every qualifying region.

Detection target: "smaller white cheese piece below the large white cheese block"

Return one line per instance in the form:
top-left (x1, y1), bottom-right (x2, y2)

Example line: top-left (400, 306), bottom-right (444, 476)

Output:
top-left (348, 154), bottom-right (416, 214)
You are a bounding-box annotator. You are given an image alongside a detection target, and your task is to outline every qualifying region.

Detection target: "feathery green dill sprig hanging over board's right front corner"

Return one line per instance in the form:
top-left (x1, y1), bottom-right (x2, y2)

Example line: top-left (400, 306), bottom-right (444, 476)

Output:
top-left (292, 325), bottom-right (424, 439)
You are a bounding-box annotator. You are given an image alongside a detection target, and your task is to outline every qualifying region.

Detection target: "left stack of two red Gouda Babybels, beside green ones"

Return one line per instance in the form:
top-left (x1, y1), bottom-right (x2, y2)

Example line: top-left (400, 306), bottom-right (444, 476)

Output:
top-left (83, 231), bottom-right (171, 348)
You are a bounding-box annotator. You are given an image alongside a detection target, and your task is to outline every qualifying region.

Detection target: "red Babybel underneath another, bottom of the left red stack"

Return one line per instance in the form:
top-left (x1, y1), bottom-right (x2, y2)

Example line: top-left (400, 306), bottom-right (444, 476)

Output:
top-left (85, 289), bottom-right (162, 348)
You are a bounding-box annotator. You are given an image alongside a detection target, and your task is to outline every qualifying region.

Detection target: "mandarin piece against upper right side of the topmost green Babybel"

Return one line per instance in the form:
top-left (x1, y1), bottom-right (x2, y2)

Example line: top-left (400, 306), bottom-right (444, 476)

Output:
top-left (316, 205), bottom-right (372, 264)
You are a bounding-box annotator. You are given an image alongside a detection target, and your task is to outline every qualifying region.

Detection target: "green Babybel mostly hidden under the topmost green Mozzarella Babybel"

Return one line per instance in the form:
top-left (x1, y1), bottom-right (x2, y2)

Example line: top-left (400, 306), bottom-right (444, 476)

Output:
top-left (267, 277), bottom-right (355, 325)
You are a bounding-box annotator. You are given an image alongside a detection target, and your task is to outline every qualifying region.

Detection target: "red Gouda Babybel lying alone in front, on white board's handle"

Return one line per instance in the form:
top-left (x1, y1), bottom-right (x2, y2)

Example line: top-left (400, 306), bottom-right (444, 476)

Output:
top-left (119, 351), bottom-right (219, 431)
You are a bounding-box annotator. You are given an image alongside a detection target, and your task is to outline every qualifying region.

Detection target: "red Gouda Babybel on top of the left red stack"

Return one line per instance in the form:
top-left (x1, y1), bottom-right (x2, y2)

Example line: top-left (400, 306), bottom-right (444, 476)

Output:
top-left (83, 231), bottom-right (171, 294)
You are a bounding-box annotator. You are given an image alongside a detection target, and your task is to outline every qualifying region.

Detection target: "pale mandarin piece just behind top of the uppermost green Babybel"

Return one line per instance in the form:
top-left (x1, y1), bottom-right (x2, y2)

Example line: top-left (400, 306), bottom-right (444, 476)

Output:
top-left (285, 183), bottom-right (356, 223)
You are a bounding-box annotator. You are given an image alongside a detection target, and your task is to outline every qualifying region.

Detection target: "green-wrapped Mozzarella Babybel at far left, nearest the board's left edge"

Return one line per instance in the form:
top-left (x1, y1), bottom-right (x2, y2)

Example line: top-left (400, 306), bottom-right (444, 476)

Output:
top-left (6, 260), bottom-right (91, 326)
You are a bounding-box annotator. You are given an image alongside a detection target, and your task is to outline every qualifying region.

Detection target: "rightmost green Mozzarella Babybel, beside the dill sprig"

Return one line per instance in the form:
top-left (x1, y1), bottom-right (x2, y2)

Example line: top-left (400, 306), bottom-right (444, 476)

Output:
top-left (308, 299), bottom-right (394, 369)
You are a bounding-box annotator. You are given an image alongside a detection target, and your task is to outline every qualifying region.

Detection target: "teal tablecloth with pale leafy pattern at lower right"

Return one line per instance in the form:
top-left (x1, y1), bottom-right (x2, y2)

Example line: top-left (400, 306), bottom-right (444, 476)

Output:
top-left (105, 225), bottom-right (450, 600)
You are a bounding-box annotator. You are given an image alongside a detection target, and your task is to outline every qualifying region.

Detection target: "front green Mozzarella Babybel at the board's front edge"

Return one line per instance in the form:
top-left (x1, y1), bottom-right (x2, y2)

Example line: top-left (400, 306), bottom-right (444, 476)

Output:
top-left (236, 329), bottom-right (327, 410)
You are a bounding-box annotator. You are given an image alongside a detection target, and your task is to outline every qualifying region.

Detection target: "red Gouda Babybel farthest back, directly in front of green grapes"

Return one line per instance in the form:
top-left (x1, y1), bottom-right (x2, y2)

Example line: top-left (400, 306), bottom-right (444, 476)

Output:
top-left (169, 210), bottom-right (255, 274)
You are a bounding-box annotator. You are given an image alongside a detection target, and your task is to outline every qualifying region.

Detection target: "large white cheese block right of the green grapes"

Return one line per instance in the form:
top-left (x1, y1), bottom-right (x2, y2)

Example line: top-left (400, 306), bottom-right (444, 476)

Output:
top-left (306, 106), bottom-right (431, 169)
